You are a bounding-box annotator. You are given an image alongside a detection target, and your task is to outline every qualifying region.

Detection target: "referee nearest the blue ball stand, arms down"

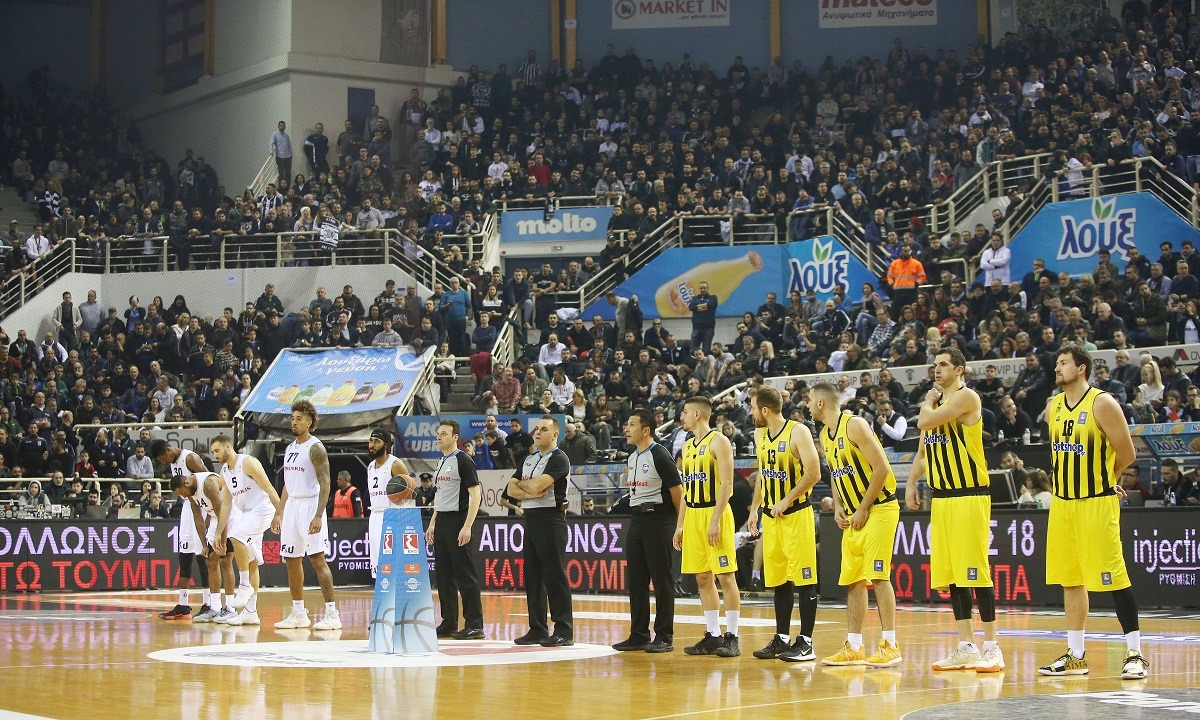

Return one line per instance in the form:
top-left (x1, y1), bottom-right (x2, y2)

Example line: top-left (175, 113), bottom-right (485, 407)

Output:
top-left (425, 420), bottom-right (484, 640)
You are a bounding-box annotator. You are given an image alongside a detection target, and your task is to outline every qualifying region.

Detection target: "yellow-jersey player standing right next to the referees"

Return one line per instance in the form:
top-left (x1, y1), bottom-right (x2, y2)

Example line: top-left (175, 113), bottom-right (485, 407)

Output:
top-left (673, 397), bottom-right (742, 658)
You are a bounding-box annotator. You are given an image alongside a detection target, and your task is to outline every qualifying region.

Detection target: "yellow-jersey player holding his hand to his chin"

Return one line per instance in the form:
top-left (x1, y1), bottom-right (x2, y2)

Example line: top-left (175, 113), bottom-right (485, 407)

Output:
top-left (905, 348), bottom-right (1004, 672)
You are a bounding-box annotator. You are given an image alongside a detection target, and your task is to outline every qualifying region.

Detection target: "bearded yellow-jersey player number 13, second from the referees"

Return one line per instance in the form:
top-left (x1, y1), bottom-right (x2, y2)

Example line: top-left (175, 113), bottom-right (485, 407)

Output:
top-left (746, 385), bottom-right (821, 662)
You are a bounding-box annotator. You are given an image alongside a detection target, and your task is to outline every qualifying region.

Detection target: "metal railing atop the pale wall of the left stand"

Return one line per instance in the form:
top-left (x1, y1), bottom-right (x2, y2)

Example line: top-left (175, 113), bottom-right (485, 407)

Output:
top-left (0, 229), bottom-right (482, 317)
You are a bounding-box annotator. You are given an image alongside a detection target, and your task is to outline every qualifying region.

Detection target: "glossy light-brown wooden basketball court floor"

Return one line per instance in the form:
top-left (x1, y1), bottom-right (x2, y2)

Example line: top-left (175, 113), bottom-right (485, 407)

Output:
top-left (0, 589), bottom-right (1200, 720)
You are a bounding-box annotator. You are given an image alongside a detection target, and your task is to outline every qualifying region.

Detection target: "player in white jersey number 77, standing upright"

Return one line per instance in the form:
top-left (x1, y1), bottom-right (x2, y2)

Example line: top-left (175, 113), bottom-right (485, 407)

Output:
top-left (271, 400), bottom-right (342, 630)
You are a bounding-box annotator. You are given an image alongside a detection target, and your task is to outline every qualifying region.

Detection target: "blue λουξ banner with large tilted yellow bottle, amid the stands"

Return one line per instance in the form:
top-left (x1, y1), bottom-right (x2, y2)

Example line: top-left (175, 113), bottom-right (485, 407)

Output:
top-left (583, 235), bottom-right (876, 320)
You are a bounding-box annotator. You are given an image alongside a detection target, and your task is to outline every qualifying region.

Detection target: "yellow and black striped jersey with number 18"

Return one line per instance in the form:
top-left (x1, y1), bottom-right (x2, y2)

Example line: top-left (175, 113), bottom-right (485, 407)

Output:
top-left (1046, 388), bottom-right (1117, 500)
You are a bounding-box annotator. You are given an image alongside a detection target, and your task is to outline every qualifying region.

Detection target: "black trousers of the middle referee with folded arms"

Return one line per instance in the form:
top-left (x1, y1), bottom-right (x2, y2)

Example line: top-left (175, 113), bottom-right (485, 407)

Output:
top-left (523, 509), bottom-right (575, 638)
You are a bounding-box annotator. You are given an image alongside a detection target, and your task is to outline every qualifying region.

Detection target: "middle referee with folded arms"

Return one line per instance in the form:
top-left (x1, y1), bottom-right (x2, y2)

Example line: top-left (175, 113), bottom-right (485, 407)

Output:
top-left (508, 415), bottom-right (575, 648)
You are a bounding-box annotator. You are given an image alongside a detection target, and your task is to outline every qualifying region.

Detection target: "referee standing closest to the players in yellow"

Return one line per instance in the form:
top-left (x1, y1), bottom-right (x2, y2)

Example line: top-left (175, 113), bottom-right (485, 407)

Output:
top-left (612, 410), bottom-right (683, 653)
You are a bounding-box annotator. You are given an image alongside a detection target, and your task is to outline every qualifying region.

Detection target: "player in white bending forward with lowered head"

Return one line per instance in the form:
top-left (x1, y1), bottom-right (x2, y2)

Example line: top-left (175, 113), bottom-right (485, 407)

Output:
top-left (170, 470), bottom-right (238, 625)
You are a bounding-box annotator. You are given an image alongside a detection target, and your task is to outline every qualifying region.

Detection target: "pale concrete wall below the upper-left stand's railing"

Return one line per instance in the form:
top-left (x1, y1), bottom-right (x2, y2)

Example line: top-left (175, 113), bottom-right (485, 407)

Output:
top-left (2, 265), bottom-right (430, 337)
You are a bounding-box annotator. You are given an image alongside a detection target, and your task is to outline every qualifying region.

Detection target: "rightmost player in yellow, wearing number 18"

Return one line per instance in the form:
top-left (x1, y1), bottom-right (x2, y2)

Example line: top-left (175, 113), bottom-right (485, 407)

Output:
top-left (1038, 346), bottom-right (1150, 680)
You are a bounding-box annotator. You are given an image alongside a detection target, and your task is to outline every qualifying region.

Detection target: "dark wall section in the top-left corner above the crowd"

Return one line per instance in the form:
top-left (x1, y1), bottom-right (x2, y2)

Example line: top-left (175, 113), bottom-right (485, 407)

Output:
top-left (0, 0), bottom-right (91, 94)
